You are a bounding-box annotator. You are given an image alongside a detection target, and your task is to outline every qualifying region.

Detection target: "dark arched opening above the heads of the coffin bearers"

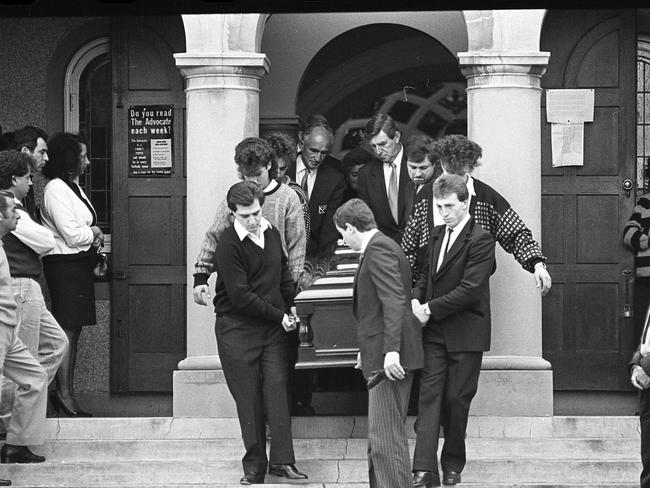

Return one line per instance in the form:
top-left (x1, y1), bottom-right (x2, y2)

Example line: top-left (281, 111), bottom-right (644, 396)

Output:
top-left (297, 24), bottom-right (467, 157)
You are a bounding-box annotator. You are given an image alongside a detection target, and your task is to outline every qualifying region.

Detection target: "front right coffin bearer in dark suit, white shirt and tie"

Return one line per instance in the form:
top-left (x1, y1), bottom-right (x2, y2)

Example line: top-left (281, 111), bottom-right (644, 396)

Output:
top-left (412, 175), bottom-right (496, 487)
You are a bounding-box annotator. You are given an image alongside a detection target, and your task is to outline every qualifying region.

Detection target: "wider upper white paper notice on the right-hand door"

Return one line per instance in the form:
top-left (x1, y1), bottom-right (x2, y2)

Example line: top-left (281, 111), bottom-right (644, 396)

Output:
top-left (546, 88), bottom-right (594, 124)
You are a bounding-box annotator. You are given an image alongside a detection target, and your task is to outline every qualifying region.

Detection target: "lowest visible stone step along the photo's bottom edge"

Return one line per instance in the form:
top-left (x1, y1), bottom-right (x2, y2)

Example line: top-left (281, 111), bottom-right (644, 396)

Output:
top-left (2, 459), bottom-right (640, 488)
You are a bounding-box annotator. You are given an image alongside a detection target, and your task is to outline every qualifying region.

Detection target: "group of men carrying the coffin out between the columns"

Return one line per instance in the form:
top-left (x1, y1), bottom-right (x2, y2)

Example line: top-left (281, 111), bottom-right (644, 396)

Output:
top-left (194, 113), bottom-right (551, 488)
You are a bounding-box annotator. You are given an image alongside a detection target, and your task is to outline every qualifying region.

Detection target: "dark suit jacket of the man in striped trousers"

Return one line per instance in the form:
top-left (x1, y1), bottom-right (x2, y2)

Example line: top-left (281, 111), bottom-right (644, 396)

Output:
top-left (353, 232), bottom-right (424, 379)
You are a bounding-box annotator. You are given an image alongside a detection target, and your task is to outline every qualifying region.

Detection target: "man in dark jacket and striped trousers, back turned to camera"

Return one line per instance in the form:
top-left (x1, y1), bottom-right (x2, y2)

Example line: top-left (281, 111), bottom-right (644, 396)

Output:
top-left (334, 198), bottom-right (423, 488)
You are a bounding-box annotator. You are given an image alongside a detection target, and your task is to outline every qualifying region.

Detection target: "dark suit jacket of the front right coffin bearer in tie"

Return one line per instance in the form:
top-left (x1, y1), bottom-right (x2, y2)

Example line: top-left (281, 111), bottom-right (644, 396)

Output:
top-left (413, 217), bottom-right (496, 352)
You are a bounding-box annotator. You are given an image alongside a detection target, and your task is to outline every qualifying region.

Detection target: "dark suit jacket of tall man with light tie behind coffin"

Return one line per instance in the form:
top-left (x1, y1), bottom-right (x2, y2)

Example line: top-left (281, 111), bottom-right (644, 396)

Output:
top-left (359, 147), bottom-right (411, 243)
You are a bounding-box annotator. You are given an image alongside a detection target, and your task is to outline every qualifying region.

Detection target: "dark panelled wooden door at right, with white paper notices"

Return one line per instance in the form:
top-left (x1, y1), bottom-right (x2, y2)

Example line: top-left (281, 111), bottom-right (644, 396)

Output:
top-left (541, 10), bottom-right (636, 390)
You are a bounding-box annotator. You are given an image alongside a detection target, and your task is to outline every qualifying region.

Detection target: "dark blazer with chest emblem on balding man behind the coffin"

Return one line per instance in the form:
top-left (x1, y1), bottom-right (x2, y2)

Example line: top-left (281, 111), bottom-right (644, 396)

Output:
top-left (287, 156), bottom-right (345, 256)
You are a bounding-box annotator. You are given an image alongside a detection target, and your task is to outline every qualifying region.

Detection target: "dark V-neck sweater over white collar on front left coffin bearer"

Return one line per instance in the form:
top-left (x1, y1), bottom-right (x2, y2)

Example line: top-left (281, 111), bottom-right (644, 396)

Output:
top-left (214, 225), bottom-right (294, 323)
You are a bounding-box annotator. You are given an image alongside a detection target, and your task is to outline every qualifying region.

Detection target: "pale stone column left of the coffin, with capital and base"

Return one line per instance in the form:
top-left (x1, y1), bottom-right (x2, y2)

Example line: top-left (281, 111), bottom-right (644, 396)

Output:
top-left (174, 14), bottom-right (269, 417)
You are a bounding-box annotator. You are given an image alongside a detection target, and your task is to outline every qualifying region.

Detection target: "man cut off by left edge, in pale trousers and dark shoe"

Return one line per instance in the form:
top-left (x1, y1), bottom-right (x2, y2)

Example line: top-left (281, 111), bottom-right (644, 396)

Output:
top-left (0, 191), bottom-right (47, 470)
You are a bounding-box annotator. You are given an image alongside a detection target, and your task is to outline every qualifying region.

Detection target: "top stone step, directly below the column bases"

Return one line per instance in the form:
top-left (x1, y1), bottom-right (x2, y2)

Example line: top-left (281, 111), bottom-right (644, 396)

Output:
top-left (47, 416), bottom-right (639, 440)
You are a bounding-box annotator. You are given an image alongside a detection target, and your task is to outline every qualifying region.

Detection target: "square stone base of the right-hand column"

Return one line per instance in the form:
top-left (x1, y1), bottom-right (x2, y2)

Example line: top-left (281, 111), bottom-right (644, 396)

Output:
top-left (470, 356), bottom-right (553, 417)
